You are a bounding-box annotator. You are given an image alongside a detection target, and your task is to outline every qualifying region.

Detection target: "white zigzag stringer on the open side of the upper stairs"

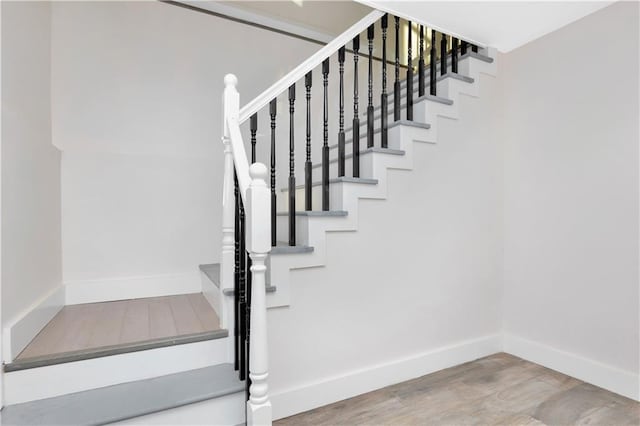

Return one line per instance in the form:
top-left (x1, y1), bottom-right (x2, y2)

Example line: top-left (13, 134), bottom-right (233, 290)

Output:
top-left (267, 49), bottom-right (497, 308)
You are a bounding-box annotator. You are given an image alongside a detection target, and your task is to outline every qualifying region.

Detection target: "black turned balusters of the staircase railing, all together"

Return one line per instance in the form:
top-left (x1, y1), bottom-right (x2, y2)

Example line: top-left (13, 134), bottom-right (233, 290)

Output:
top-left (233, 14), bottom-right (479, 385)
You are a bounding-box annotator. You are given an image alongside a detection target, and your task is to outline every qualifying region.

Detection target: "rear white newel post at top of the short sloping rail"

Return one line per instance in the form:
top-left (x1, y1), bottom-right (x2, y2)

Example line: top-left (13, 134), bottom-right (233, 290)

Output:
top-left (220, 74), bottom-right (240, 328)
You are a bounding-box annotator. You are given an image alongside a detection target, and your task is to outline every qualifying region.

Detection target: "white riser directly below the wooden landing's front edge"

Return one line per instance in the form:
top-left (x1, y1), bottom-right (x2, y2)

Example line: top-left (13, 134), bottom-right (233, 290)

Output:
top-left (5, 337), bottom-right (229, 405)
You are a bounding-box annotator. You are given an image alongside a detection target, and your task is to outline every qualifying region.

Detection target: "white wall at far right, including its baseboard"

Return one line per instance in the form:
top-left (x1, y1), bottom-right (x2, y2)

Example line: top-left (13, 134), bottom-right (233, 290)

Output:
top-left (501, 2), bottom-right (640, 398)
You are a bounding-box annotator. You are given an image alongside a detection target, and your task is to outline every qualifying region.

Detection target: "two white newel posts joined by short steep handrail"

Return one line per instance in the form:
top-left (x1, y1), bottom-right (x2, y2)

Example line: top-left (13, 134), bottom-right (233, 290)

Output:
top-left (220, 74), bottom-right (272, 426)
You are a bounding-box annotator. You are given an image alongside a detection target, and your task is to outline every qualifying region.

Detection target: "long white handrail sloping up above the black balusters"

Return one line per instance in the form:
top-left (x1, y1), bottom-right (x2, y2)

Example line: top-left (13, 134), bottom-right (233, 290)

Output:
top-left (238, 10), bottom-right (384, 124)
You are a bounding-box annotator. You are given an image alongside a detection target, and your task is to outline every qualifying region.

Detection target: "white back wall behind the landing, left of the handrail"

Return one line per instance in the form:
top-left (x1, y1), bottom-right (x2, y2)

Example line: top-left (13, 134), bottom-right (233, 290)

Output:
top-left (52, 2), bottom-right (319, 303)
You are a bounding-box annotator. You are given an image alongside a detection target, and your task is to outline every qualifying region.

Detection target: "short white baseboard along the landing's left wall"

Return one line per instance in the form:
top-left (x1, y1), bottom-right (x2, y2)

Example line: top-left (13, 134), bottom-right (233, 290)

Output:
top-left (2, 285), bottom-right (65, 362)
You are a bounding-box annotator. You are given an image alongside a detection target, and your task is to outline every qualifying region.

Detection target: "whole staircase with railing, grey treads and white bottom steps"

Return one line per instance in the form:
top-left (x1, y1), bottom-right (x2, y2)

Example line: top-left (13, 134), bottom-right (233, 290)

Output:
top-left (2, 6), bottom-right (497, 425)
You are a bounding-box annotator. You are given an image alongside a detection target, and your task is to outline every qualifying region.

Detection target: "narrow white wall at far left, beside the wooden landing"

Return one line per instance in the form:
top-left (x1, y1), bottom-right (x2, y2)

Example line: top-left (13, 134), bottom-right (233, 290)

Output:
top-left (2, 2), bottom-right (62, 361)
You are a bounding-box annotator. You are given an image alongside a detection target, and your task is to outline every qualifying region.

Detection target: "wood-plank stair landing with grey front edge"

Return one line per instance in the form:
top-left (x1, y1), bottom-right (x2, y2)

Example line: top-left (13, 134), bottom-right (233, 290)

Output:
top-left (5, 293), bottom-right (228, 372)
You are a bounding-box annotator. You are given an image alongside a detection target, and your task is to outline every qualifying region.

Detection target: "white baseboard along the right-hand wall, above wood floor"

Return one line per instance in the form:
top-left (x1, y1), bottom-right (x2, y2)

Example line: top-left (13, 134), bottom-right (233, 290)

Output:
top-left (504, 334), bottom-right (640, 401)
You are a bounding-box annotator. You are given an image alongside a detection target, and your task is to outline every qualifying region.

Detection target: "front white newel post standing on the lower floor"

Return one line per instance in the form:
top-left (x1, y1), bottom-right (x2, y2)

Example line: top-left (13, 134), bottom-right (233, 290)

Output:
top-left (246, 163), bottom-right (271, 426)
